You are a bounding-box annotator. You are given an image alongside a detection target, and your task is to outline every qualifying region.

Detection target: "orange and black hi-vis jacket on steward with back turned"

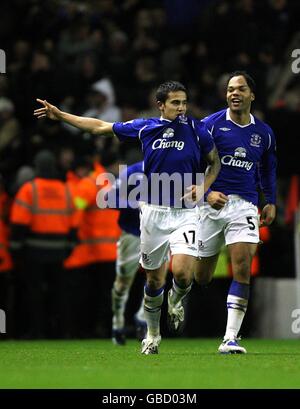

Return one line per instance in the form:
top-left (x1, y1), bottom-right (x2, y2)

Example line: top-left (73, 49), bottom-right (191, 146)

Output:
top-left (10, 178), bottom-right (75, 262)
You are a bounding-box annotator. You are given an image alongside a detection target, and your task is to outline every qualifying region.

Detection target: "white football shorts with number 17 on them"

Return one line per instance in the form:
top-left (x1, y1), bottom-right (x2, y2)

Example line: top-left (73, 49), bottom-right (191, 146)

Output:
top-left (140, 203), bottom-right (199, 270)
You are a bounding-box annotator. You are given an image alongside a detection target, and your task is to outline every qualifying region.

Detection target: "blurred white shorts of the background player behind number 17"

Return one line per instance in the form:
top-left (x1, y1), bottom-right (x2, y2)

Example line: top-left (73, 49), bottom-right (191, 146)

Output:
top-left (116, 230), bottom-right (141, 277)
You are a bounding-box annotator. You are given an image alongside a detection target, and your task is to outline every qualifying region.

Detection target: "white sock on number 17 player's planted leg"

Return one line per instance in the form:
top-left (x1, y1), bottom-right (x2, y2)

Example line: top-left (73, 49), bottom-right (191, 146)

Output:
top-left (144, 288), bottom-right (164, 337)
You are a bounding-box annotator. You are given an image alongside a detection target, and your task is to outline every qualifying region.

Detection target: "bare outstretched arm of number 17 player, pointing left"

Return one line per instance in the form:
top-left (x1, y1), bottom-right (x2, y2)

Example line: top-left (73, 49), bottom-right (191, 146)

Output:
top-left (33, 99), bottom-right (113, 134)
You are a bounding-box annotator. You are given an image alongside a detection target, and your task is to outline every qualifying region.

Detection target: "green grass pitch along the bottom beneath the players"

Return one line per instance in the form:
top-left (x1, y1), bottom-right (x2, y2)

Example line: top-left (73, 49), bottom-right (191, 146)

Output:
top-left (0, 339), bottom-right (300, 389)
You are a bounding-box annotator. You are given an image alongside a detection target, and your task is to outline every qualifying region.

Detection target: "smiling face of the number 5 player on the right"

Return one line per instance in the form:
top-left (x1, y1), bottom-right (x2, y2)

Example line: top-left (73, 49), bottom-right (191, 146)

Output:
top-left (226, 75), bottom-right (254, 112)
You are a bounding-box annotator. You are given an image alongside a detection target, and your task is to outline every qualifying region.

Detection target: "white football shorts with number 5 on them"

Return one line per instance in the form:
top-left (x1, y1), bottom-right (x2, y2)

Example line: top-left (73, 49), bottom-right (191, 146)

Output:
top-left (198, 195), bottom-right (259, 257)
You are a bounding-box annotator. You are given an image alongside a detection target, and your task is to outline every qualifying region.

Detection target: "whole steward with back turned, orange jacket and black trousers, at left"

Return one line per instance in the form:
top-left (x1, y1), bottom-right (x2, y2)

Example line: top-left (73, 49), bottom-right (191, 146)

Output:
top-left (10, 151), bottom-right (76, 338)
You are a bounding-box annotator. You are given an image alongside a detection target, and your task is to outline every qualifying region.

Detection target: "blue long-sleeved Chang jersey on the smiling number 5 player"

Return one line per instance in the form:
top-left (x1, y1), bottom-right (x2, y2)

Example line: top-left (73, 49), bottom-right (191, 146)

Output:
top-left (202, 108), bottom-right (276, 205)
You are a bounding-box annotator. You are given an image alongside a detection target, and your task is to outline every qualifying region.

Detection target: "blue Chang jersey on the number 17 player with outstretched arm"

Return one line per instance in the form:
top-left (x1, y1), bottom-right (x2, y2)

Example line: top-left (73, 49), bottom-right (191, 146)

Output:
top-left (113, 115), bottom-right (214, 207)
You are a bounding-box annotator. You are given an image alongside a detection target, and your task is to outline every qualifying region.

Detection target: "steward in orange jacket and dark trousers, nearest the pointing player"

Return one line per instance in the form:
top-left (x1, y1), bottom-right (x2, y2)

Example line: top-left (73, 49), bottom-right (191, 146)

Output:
top-left (64, 164), bottom-right (120, 338)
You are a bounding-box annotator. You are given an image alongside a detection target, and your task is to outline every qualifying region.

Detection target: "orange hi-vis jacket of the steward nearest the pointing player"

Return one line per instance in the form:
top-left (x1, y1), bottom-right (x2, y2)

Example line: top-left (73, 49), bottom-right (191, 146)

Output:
top-left (64, 164), bottom-right (121, 268)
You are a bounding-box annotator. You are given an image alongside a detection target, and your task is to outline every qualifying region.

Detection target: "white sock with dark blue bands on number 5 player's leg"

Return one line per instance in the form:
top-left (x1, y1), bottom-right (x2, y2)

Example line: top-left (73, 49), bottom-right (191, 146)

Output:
top-left (224, 294), bottom-right (248, 339)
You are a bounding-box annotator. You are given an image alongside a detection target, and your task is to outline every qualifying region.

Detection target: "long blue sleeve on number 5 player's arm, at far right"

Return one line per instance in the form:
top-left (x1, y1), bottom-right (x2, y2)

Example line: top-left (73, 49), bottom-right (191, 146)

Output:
top-left (260, 126), bottom-right (277, 204)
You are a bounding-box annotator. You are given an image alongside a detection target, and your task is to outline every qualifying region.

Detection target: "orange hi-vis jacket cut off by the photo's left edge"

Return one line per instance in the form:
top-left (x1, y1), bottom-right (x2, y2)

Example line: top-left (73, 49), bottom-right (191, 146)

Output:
top-left (0, 192), bottom-right (13, 273)
